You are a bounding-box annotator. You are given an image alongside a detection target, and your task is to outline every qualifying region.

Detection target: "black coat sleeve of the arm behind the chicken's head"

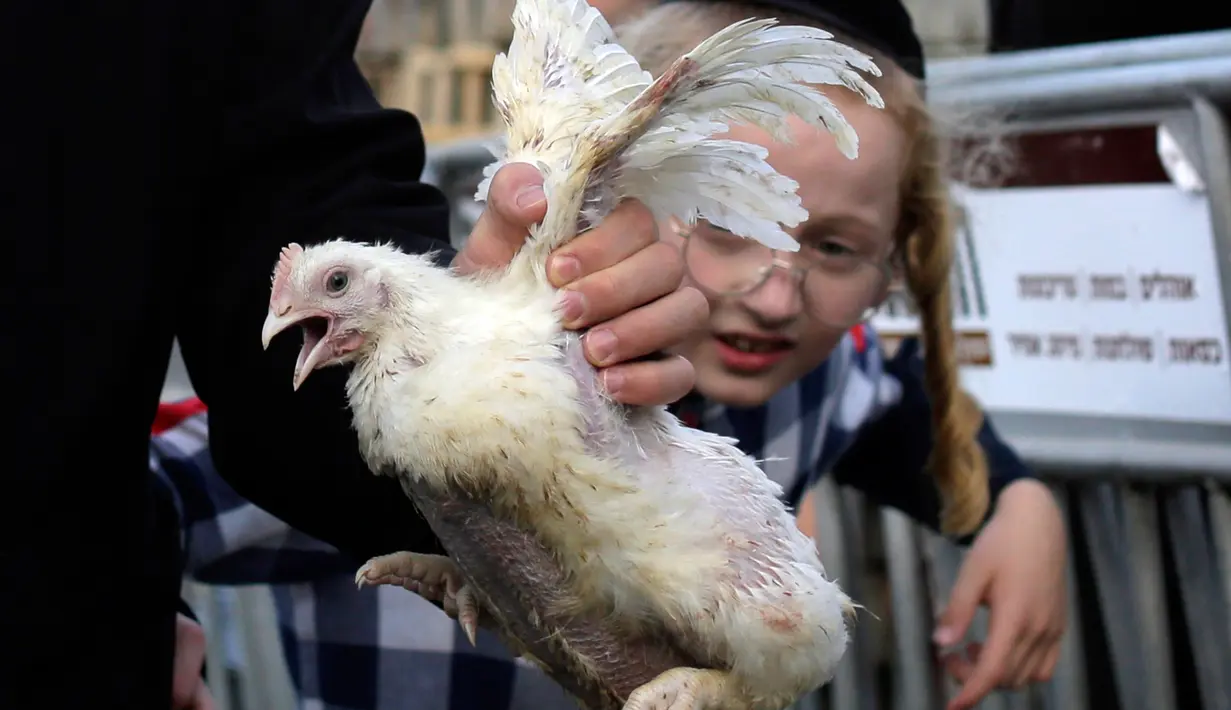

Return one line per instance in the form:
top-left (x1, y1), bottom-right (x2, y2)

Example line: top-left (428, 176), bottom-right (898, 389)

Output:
top-left (177, 0), bottom-right (452, 560)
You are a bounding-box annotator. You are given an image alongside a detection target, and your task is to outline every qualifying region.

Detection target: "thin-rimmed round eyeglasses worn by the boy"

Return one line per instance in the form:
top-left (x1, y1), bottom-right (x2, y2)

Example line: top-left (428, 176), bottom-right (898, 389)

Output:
top-left (672, 219), bottom-right (894, 330)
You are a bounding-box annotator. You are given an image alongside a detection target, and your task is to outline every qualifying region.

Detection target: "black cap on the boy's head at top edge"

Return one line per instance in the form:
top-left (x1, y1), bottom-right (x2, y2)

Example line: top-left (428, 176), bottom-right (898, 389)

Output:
top-left (661, 0), bottom-right (923, 79)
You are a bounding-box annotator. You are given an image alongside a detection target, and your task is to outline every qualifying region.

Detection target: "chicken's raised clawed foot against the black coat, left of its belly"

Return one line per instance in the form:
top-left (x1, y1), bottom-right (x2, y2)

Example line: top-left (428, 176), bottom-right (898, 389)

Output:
top-left (355, 552), bottom-right (479, 646)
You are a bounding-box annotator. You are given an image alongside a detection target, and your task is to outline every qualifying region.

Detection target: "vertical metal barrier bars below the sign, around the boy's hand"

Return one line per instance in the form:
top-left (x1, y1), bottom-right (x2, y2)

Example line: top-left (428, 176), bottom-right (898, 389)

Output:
top-left (816, 470), bottom-right (1231, 710)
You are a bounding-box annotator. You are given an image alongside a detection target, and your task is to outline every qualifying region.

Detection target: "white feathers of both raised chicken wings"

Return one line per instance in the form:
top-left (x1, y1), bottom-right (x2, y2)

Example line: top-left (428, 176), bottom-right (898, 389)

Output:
top-left (475, 0), bottom-right (884, 251)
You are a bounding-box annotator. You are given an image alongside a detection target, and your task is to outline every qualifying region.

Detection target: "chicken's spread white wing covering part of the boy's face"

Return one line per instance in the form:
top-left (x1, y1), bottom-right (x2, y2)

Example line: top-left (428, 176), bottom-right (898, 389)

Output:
top-left (617, 20), bottom-right (884, 251)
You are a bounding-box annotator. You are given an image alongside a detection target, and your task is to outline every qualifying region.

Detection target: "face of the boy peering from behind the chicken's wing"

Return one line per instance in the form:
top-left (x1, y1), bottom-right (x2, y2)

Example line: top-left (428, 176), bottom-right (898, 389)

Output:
top-left (659, 87), bottom-right (906, 406)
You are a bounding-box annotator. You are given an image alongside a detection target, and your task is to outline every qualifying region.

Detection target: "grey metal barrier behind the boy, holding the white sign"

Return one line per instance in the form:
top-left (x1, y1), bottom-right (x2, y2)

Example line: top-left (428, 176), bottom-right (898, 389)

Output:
top-left (184, 27), bottom-right (1231, 710)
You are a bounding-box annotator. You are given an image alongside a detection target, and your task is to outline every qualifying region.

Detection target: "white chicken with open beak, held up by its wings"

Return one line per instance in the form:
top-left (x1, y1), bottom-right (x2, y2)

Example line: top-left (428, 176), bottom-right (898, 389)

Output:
top-left (262, 0), bottom-right (881, 710)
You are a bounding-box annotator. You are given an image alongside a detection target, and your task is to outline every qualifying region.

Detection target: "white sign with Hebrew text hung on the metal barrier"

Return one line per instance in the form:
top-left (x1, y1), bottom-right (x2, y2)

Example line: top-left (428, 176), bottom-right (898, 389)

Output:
top-left (872, 185), bottom-right (1231, 423)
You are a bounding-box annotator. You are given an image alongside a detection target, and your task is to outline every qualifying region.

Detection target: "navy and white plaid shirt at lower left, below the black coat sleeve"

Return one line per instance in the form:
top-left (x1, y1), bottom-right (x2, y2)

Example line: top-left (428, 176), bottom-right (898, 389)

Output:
top-left (150, 399), bottom-right (577, 710)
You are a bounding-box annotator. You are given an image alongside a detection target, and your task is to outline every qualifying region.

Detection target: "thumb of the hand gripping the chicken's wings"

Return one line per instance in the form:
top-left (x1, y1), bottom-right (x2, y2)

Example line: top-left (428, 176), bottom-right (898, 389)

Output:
top-left (453, 162), bottom-right (547, 273)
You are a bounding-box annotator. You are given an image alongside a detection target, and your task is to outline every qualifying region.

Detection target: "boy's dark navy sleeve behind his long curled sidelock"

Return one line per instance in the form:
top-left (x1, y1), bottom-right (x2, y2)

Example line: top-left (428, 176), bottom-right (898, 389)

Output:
top-left (833, 338), bottom-right (1032, 541)
